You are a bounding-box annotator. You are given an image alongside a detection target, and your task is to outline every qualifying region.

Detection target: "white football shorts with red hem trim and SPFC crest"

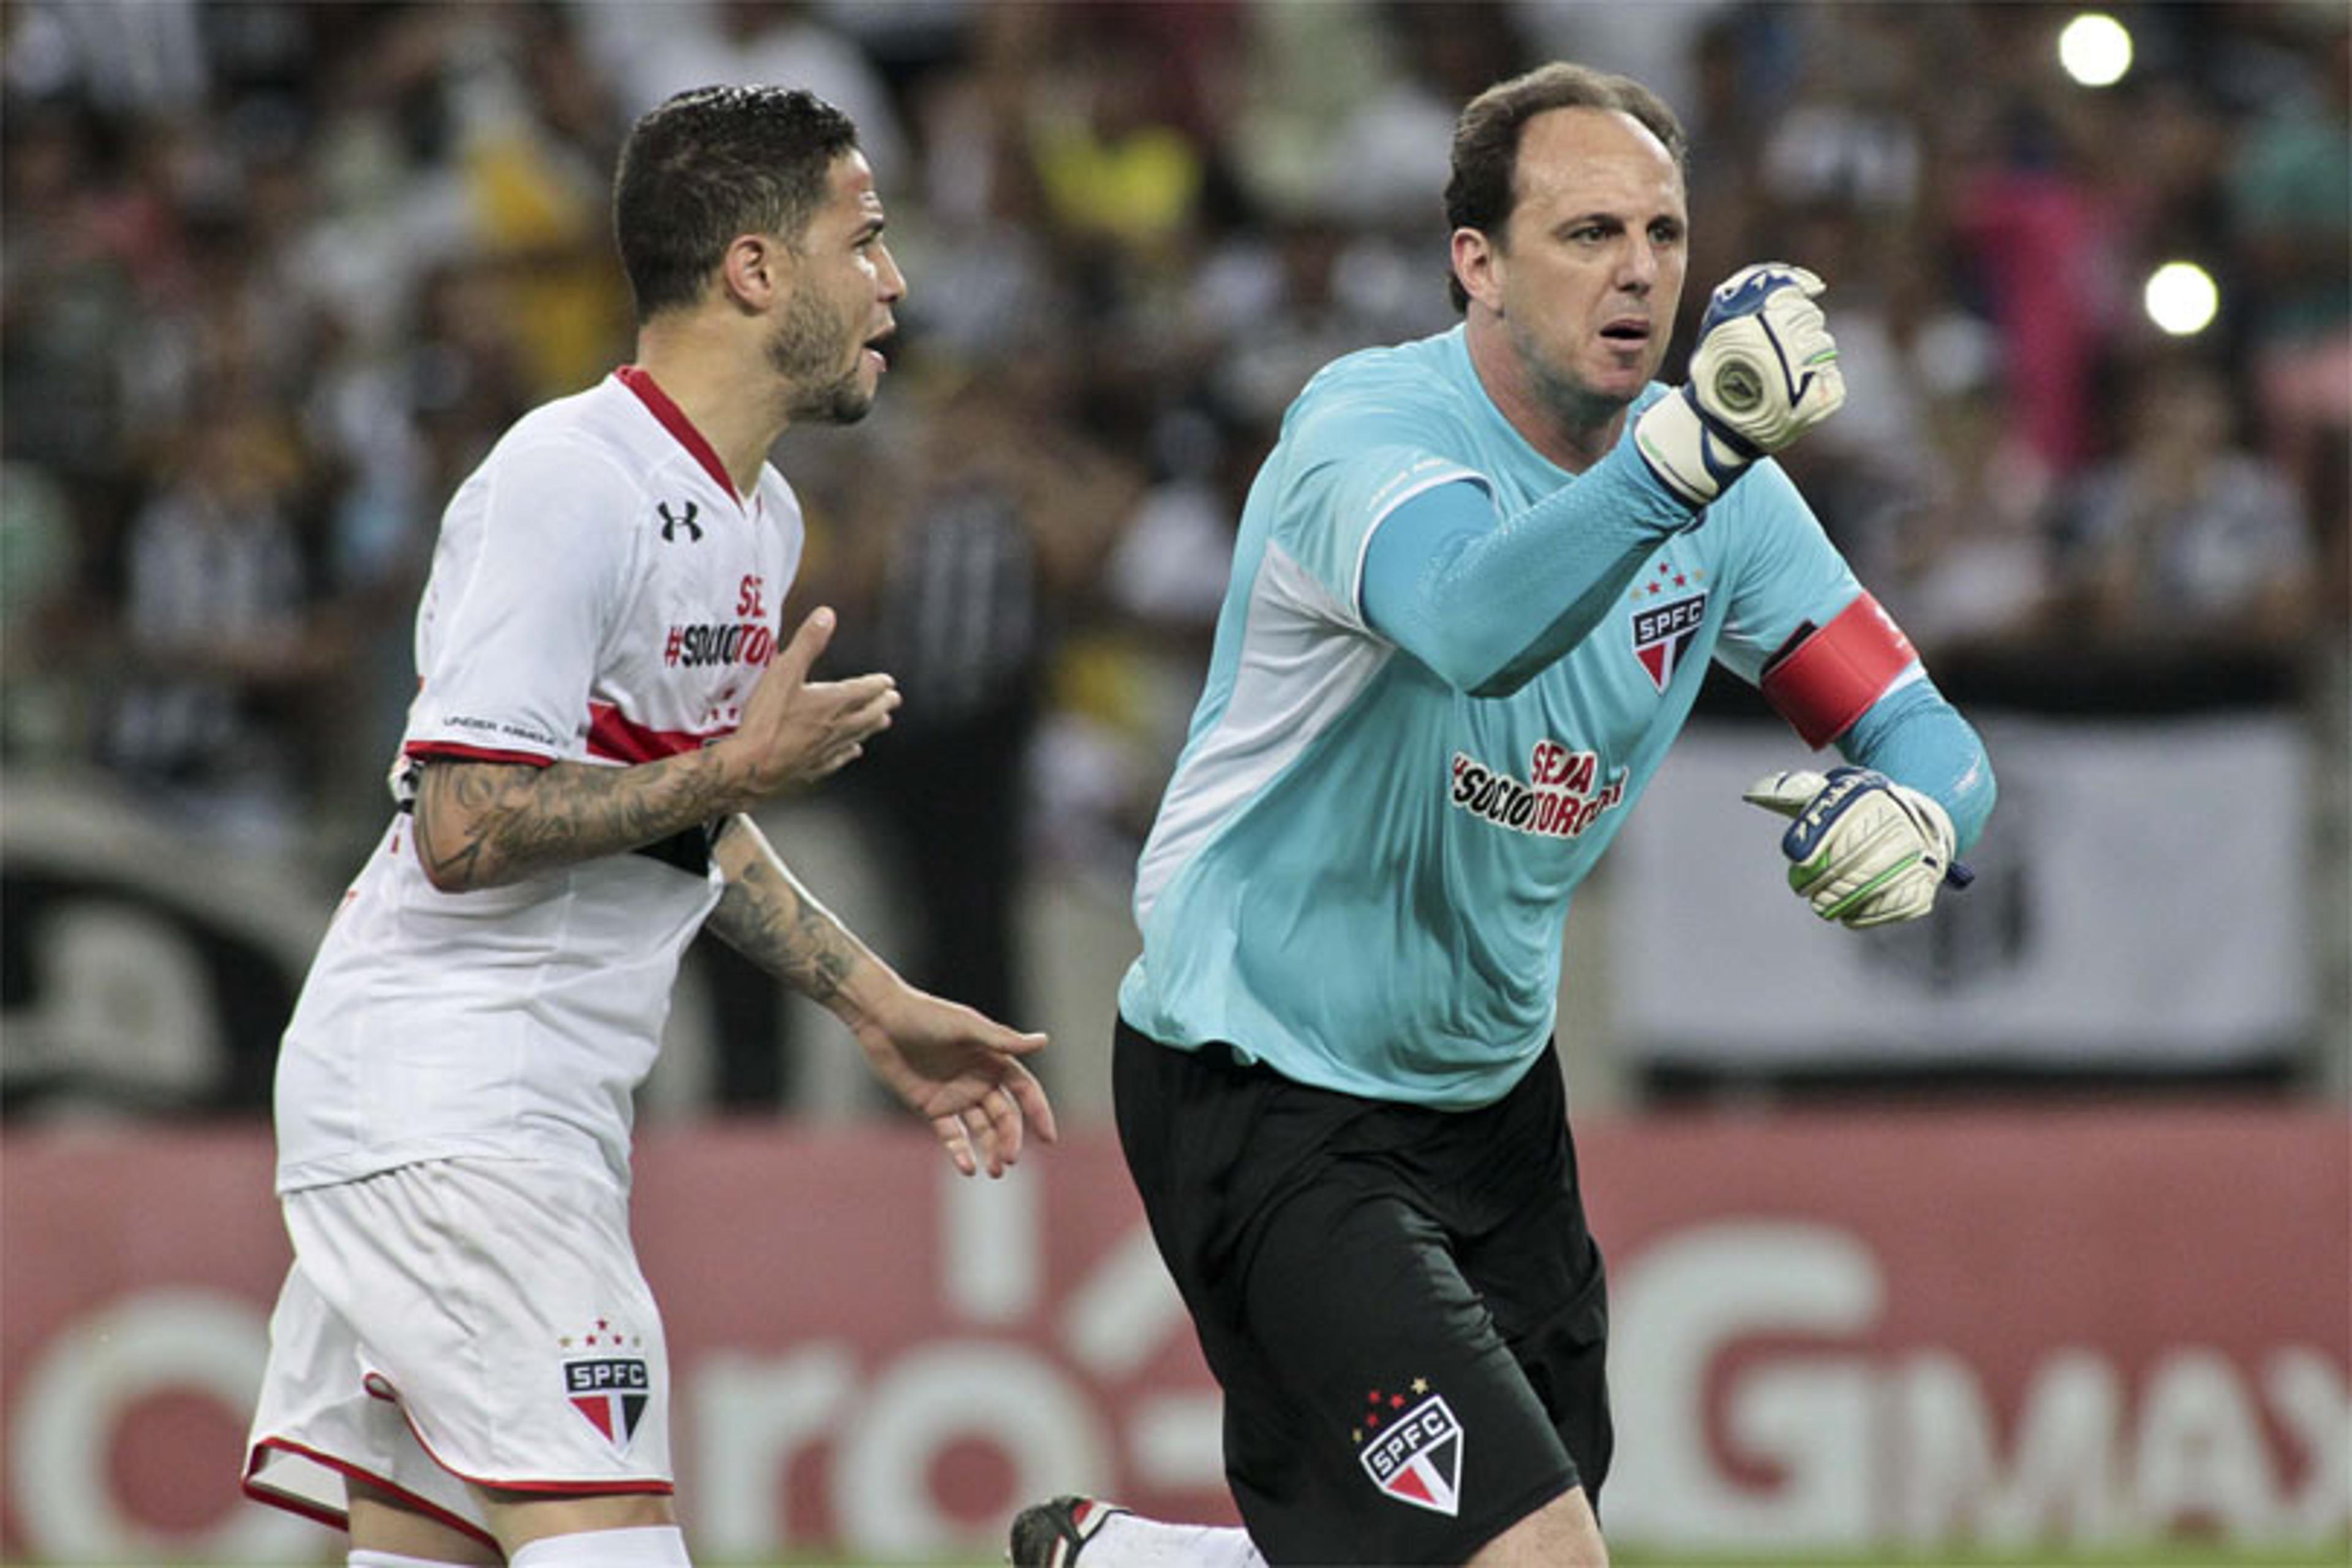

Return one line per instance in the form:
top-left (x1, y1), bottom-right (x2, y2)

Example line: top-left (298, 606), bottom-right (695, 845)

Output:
top-left (244, 1159), bottom-right (673, 1540)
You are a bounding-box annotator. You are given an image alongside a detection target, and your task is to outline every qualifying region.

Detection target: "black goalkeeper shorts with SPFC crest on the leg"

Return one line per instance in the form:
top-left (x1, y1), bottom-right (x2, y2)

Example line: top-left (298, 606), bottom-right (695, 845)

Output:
top-left (1112, 1020), bottom-right (1611, 1566)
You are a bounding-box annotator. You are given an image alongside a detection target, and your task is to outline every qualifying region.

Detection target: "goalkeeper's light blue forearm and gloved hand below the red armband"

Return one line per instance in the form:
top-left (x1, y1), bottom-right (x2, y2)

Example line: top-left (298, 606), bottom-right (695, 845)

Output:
top-left (1747, 673), bottom-right (1994, 929)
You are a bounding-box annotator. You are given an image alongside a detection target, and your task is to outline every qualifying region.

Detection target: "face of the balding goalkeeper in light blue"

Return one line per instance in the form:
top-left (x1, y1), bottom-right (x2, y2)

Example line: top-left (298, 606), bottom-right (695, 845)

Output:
top-left (1479, 108), bottom-right (1689, 423)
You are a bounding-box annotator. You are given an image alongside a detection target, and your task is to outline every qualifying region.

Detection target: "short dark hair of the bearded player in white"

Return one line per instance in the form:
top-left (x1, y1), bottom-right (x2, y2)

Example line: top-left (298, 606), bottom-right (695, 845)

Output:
top-left (611, 87), bottom-right (859, 325)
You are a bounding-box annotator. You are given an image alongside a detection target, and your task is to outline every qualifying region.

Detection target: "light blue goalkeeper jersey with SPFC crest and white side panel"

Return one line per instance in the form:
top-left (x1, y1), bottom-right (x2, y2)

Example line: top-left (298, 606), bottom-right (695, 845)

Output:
top-left (1120, 326), bottom-right (1860, 1110)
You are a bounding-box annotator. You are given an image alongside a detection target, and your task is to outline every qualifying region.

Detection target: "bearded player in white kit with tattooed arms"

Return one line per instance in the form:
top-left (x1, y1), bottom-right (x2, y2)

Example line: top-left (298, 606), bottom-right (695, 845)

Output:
top-left (244, 87), bottom-right (1054, 1568)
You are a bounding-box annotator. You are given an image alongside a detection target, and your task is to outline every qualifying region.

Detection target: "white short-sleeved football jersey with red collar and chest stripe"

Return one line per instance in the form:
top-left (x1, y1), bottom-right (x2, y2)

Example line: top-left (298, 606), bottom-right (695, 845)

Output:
top-left (277, 367), bottom-right (802, 1192)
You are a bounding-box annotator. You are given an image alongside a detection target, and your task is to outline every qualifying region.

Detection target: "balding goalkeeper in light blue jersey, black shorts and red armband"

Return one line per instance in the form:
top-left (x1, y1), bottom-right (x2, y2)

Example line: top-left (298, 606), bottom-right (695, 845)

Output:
top-left (1011, 64), bottom-right (1992, 1568)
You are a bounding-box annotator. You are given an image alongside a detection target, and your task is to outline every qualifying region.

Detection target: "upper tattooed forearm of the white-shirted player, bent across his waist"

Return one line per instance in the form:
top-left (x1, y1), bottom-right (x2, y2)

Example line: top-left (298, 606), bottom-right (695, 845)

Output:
top-left (417, 757), bottom-right (725, 893)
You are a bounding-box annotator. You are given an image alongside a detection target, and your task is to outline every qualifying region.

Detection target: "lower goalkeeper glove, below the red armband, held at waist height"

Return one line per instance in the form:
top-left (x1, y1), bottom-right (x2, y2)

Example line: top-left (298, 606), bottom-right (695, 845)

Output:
top-left (1743, 766), bottom-right (1971, 931)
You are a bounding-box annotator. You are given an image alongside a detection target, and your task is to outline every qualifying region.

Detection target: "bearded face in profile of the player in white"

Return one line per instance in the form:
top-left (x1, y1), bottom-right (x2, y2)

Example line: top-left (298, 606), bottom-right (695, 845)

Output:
top-left (767, 153), bottom-right (905, 426)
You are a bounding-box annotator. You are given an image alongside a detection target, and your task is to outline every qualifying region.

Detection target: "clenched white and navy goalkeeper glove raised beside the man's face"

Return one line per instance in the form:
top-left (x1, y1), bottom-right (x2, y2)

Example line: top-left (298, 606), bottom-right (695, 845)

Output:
top-left (1632, 261), bottom-right (1846, 505)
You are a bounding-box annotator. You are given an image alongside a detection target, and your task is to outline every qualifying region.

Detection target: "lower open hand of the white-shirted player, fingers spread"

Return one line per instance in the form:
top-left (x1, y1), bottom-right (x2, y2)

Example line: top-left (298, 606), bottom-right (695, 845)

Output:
top-left (851, 985), bottom-right (1056, 1175)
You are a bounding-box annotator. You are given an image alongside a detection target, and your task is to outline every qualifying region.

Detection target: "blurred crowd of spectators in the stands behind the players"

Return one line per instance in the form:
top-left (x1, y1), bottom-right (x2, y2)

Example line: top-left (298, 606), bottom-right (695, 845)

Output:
top-left (0, 0), bottom-right (2352, 1104)
